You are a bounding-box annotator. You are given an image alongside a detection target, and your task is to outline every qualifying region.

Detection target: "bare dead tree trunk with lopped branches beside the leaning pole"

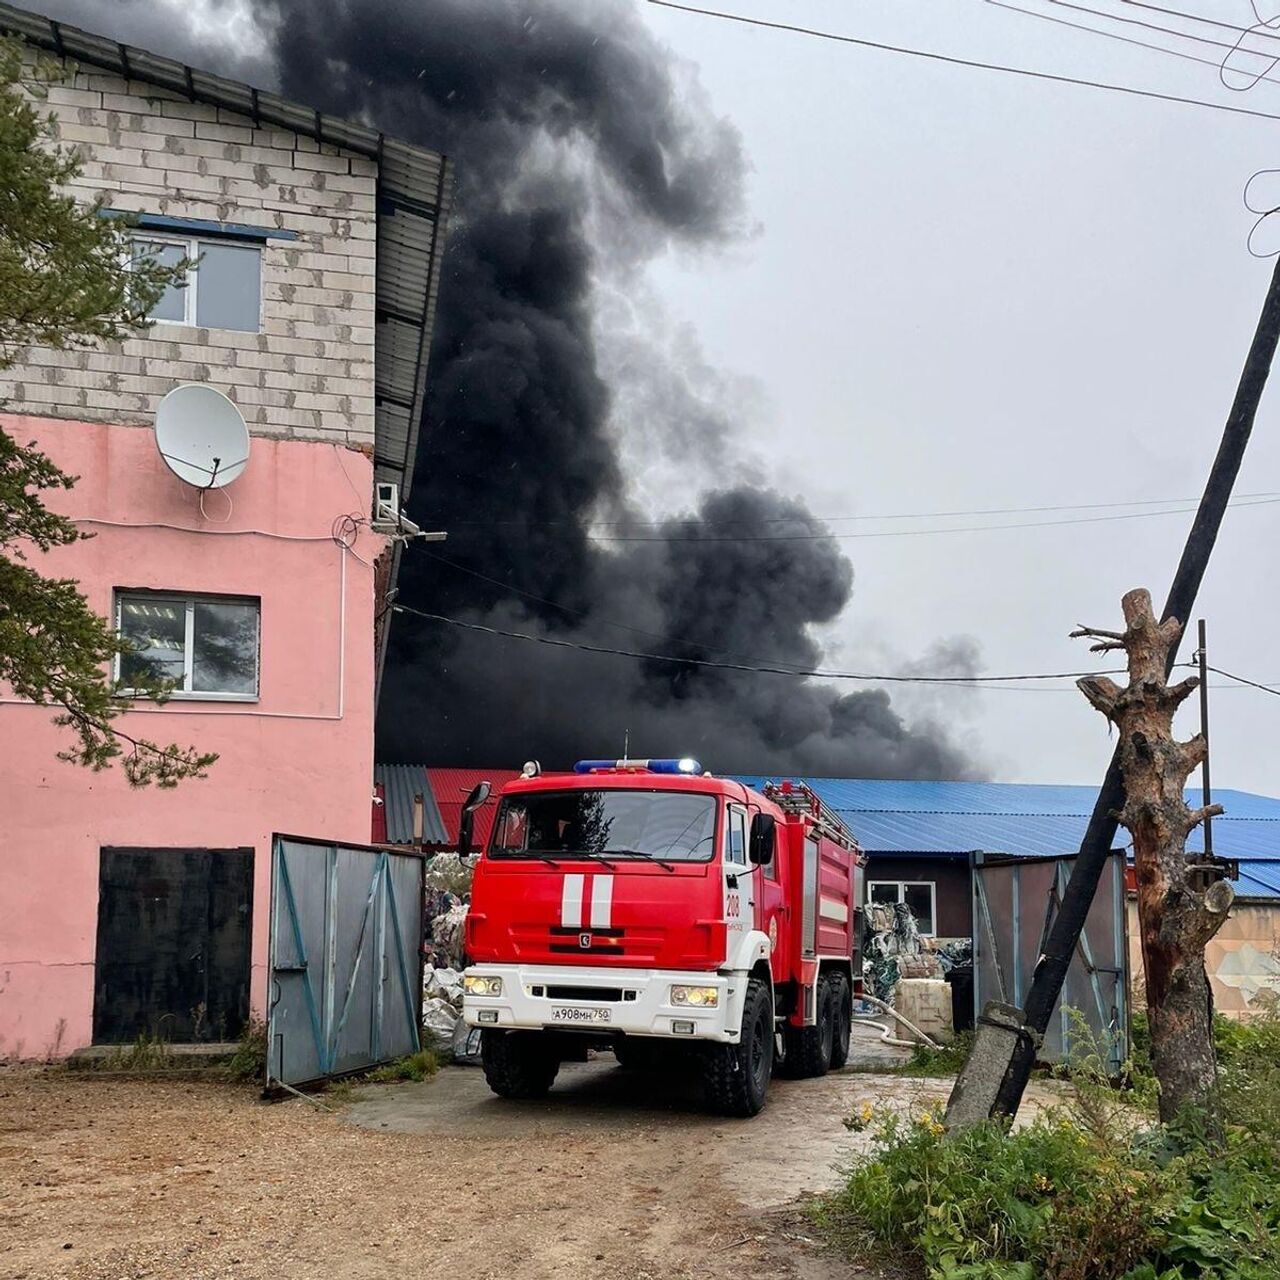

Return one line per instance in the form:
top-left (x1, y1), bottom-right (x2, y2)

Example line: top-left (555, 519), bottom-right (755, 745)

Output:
top-left (1071, 589), bottom-right (1234, 1135)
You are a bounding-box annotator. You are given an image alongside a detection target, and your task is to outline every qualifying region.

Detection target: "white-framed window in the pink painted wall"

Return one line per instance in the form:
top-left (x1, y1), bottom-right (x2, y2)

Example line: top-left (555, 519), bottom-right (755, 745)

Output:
top-left (115, 591), bottom-right (260, 701)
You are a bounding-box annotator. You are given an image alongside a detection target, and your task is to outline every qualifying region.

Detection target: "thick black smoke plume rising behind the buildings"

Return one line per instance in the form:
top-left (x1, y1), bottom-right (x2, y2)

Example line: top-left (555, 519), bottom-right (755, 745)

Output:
top-left (47, 0), bottom-right (977, 777)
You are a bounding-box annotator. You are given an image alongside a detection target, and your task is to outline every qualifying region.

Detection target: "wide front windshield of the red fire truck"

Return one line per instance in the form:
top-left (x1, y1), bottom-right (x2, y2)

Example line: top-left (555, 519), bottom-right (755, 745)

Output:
top-left (489, 788), bottom-right (716, 863)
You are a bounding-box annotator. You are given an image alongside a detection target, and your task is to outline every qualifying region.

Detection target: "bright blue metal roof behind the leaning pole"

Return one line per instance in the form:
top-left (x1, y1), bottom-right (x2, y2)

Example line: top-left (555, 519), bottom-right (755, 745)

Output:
top-left (736, 776), bottom-right (1280, 897)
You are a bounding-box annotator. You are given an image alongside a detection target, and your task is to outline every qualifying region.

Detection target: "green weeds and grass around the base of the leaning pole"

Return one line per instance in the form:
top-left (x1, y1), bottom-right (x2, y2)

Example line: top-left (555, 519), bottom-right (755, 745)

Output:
top-left (812, 1014), bottom-right (1280, 1280)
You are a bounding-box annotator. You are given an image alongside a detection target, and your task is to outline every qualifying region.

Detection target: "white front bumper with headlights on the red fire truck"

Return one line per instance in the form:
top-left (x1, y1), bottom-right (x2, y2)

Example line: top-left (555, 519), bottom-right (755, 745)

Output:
top-left (462, 964), bottom-right (746, 1041)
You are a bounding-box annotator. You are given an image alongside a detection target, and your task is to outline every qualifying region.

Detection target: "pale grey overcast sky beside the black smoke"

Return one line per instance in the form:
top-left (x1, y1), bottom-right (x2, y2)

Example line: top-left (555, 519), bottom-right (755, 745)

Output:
top-left (33, 0), bottom-right (1280, 794)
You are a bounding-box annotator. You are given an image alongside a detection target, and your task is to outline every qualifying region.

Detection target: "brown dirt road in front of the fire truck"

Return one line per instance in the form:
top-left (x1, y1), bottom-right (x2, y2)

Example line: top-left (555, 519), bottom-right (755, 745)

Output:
top-left (0, 1059), bottom-right (962, 1280)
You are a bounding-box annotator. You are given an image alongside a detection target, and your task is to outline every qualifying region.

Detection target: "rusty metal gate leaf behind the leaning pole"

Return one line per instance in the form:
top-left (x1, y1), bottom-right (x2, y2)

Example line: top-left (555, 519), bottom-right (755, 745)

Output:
top-left (970, 850), bottom-right (1129, 1075)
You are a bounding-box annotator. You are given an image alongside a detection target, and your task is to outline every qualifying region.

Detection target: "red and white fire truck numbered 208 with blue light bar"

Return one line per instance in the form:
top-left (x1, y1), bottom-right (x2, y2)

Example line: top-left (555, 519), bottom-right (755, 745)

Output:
top-left (460, 759), bottom-right (865, 1116)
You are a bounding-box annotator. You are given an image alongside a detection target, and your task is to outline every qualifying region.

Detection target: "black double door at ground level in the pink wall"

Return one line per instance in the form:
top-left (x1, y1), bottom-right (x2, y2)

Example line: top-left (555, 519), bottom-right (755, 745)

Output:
top-left (93, 849), bottom-right (253, 1044)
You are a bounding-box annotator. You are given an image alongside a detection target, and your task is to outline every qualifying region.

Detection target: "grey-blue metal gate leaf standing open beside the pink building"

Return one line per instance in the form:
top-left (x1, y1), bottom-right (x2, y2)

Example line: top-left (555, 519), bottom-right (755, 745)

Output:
top-left (266, 836), bottom-right (422, 1088)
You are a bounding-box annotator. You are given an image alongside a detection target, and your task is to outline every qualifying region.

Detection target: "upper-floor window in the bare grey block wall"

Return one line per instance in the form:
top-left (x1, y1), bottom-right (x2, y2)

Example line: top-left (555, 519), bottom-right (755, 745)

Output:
top-left (133, 234), bottom-right (262, 333)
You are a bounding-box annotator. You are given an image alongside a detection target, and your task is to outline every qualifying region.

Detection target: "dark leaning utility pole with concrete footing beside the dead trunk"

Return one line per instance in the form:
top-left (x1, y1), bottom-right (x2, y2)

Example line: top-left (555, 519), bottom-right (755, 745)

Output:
top-left (947, 257), bottom-right (1280, 1128)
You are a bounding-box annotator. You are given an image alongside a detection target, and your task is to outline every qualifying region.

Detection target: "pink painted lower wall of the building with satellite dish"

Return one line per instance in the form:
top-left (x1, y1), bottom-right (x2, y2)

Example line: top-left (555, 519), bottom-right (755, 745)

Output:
top-left (0, 415), bottom-right (383, 1057)
